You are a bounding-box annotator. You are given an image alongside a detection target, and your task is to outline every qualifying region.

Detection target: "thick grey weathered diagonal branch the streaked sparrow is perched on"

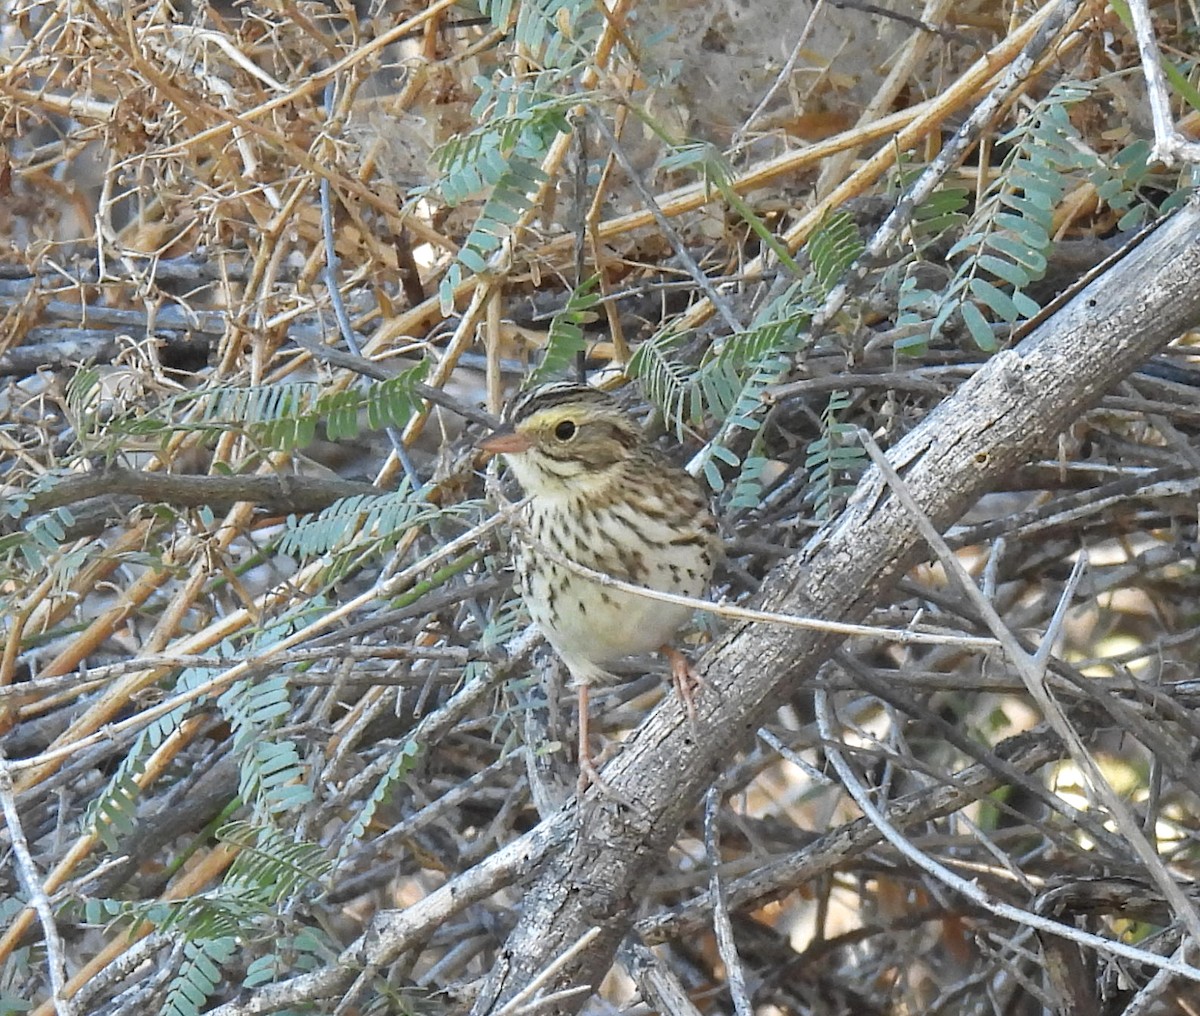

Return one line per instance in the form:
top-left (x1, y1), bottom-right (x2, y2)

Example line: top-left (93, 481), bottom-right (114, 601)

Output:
top-left (472, 202), bottom-right (1200, 1016)
